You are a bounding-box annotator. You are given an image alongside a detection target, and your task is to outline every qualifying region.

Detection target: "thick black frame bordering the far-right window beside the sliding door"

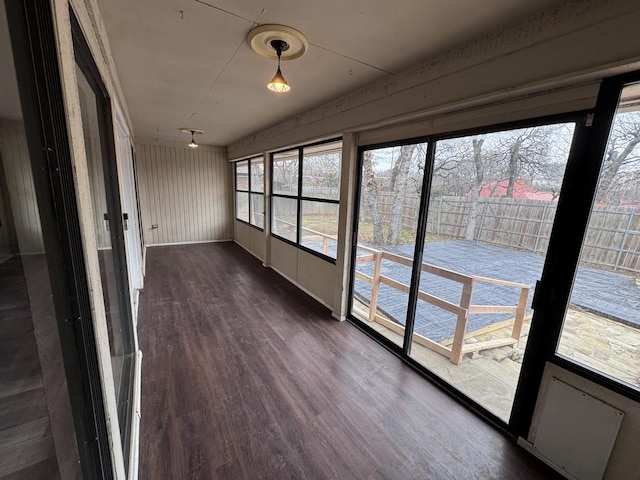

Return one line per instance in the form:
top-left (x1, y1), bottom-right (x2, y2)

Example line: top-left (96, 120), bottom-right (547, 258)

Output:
top-left (510, 71), bottom-right (640, 437)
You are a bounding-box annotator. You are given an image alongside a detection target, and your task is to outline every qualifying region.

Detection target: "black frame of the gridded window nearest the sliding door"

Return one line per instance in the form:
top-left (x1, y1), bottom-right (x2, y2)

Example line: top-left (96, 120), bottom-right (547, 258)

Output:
top-left (269, 137), bottom-right (343, 265)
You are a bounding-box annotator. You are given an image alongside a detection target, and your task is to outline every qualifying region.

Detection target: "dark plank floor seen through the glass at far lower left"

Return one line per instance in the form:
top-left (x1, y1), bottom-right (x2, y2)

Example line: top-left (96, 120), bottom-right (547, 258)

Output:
top-left (0, 256), bottom-right (59, 480)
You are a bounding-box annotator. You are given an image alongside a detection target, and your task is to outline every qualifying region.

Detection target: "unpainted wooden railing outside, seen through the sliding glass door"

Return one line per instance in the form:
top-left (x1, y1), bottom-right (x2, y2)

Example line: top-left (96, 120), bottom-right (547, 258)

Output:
top-left (356, 245), bottom-right (531, 365)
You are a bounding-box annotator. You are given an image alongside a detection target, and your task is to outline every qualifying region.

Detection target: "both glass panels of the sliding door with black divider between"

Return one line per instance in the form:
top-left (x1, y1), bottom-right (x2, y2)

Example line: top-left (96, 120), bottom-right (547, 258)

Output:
top-left (350, 117), bottom-right (575, 424)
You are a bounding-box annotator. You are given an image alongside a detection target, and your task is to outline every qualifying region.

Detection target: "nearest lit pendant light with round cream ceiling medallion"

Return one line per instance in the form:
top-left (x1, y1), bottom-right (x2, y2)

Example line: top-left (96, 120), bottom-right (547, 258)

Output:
top-left (247, 25), bottom-right (309, 93)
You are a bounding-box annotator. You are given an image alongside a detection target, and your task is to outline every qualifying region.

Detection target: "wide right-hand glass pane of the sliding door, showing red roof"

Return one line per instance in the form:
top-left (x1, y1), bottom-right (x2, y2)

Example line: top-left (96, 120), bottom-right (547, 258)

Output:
top-left (410, 123), bottom-right (574, 422)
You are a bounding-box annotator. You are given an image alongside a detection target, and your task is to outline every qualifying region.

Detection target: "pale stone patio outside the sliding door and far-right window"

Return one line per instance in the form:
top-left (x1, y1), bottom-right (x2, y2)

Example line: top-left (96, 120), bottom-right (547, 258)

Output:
top-left (367, 309), bottom-right (640, 421)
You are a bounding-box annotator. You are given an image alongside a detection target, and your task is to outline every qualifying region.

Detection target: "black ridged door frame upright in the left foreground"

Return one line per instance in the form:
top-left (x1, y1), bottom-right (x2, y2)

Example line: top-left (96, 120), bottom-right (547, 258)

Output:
top-left (5, 0), bottom-right (114, 479)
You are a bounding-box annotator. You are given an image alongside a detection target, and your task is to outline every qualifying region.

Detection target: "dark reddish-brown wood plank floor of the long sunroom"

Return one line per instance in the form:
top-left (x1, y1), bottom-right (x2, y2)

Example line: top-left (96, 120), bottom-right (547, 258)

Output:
top-left (139, 243), bottom-right (552, 480)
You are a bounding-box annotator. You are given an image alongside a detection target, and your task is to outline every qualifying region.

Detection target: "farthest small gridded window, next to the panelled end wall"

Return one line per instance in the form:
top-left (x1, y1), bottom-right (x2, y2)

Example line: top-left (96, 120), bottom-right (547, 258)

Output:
top-left (235, 157), bottom-right (264, 229)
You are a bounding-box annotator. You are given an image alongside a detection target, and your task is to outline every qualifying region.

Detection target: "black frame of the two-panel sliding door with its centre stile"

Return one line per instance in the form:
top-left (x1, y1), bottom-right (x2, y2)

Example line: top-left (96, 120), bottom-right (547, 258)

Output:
top-left (347, 109), bottom-right (592, 436)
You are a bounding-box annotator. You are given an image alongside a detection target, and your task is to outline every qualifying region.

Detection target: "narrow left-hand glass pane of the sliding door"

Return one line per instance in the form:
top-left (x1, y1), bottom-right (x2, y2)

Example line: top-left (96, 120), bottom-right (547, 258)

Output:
top-left (351, 143), bottom-right (427, 346)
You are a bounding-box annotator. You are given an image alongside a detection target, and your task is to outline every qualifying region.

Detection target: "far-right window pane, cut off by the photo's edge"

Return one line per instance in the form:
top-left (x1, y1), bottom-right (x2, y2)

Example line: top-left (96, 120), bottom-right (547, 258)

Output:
top-left (556, 82), bottom-right (640, 394)
